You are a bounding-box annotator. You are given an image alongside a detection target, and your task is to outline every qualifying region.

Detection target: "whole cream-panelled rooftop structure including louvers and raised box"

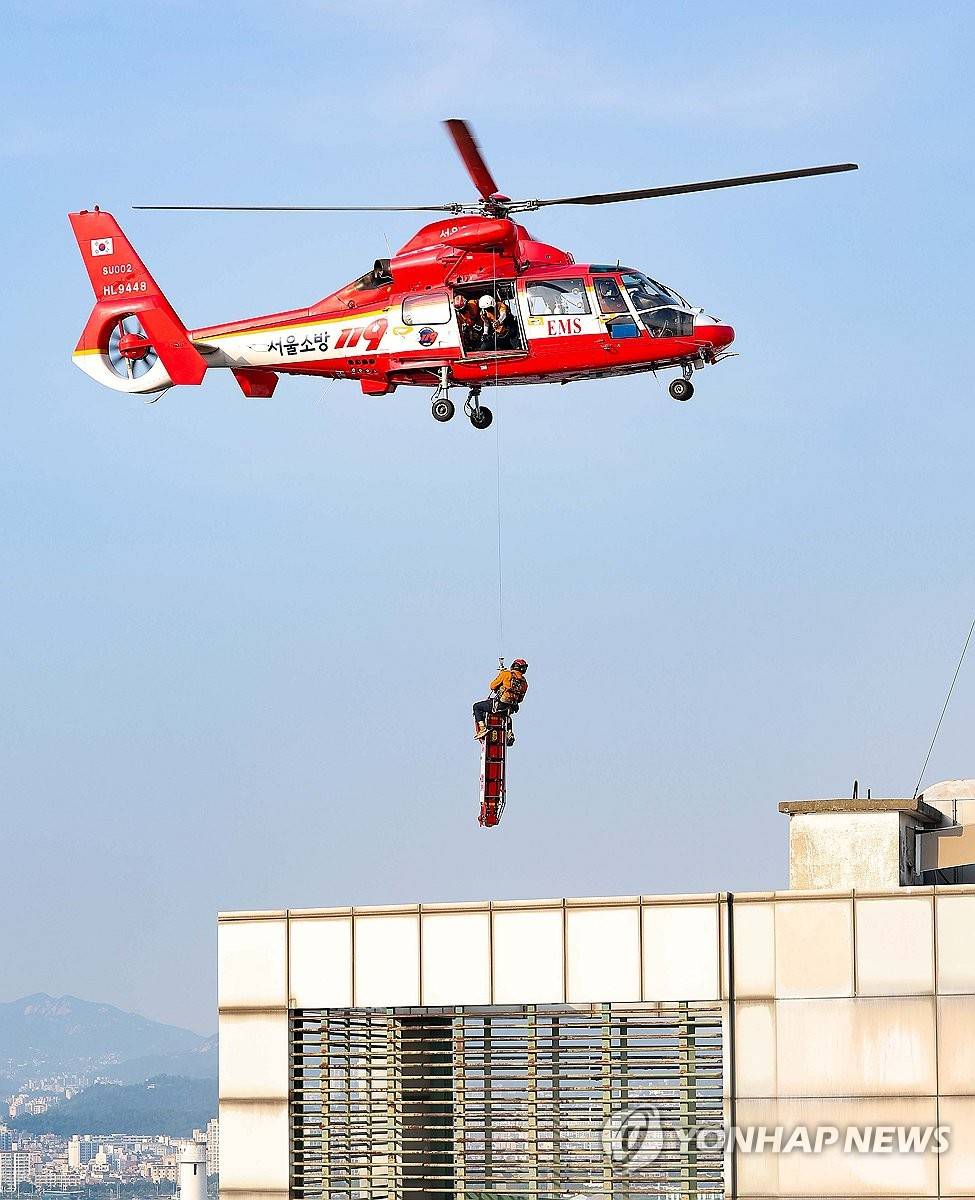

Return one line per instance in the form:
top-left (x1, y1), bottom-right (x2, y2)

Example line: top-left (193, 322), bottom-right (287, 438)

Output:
top-left (219, 781), bottom-right (975, 1200)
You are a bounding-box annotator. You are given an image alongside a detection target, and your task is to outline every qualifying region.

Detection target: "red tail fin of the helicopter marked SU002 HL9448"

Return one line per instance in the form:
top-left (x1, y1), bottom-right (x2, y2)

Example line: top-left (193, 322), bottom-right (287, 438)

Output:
top-left (68, 209), bottom-right (207, 391)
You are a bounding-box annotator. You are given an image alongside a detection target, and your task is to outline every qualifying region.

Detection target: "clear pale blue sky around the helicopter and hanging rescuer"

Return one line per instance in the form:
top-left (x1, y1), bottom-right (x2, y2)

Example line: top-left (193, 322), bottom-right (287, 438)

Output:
top-left (0, 0), bottom-right (975, 1031)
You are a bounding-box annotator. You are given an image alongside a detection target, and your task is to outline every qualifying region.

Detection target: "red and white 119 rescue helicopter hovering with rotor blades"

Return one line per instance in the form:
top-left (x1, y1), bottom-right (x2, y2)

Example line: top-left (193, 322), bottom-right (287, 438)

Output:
top-left (70, 120), bottom-right (856, 428)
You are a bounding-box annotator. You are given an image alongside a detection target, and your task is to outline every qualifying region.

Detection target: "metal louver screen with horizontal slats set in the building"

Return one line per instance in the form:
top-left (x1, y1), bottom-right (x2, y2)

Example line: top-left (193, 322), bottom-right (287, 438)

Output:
top-left (291, 1004), bottom-right (723, 1200)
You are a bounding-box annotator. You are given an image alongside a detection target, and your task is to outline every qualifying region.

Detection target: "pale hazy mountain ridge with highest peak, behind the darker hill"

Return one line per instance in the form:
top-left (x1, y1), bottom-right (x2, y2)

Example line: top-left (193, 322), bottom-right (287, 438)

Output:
top-left (0, 992), bottom-right (216, 1086)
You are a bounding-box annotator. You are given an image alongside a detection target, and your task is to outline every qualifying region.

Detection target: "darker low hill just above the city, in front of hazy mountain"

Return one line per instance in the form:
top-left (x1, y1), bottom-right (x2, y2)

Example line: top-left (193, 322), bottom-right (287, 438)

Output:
top-left (10, 1075), bottom-right (216, 1138)
